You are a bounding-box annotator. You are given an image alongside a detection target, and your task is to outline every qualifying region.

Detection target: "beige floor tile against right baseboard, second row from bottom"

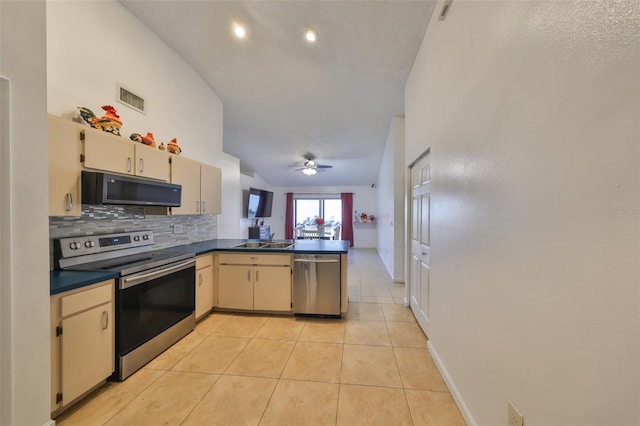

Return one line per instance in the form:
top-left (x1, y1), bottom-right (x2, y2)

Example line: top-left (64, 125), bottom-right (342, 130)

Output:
top-left (393, 348), bottom-right (449, 392)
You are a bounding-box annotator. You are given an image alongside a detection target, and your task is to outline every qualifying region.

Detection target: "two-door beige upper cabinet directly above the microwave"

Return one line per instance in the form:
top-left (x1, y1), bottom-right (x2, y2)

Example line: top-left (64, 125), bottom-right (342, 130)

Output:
top-left (81, 127), bottom-right (169, 181)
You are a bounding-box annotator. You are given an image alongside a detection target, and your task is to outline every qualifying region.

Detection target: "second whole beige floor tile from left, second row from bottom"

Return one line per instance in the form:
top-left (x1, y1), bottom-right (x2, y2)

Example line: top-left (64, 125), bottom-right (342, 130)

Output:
top-left (225, 339), bottom-right (295, 378)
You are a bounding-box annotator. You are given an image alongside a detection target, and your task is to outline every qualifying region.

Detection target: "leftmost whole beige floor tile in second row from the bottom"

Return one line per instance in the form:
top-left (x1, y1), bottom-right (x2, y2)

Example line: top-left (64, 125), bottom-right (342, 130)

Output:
top-left (172, 335), bottom-right (249, 374)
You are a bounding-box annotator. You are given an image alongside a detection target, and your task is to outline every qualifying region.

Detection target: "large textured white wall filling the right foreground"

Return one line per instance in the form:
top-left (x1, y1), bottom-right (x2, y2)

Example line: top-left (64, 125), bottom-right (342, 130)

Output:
top-left (405, 1), bottom-right (640, 426)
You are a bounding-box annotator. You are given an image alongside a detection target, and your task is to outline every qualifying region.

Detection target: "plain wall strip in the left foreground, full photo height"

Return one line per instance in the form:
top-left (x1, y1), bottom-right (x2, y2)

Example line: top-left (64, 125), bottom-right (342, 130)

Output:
top-left (0, 1), bottom-right (50, 425)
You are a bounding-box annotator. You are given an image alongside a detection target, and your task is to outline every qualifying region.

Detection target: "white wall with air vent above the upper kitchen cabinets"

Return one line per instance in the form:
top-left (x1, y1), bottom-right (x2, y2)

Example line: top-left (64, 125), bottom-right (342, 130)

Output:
top-left (47, 1), bottom-right (241, 238)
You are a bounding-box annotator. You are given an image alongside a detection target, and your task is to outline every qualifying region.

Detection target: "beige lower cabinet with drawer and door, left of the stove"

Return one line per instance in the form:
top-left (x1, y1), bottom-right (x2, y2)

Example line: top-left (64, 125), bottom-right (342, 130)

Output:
top-left (51, 280), bottom-right (115, 414)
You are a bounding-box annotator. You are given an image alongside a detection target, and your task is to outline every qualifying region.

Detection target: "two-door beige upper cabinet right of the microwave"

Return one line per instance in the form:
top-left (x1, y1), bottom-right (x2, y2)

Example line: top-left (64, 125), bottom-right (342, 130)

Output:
top-left (171, 156), bottom-right (222, 214)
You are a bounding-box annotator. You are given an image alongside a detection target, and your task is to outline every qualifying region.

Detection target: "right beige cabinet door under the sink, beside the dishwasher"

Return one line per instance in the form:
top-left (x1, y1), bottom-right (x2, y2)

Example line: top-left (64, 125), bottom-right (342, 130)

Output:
top-left (253, 266), bottom-right (291, 312)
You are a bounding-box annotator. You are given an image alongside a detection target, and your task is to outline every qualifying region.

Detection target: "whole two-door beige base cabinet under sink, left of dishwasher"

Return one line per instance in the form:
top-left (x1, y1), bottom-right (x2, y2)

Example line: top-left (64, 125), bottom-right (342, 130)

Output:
top-left (218, 253), bottom-right (291, 312)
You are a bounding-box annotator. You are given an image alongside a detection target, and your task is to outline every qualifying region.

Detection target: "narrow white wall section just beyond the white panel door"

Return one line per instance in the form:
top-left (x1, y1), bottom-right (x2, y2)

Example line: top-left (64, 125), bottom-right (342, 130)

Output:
top-left (376, 117), bottom-right (406, 282)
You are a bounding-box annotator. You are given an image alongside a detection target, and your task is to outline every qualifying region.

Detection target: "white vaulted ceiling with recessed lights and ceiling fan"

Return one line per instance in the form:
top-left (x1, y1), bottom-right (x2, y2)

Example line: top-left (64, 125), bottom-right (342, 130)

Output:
top-left (120, 0), bottom-right (435, 186)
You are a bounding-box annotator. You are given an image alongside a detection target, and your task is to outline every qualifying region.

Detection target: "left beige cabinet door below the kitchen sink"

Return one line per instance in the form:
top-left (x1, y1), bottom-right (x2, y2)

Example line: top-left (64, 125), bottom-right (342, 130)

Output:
top-left (218, 265), bottom-right (253, 310)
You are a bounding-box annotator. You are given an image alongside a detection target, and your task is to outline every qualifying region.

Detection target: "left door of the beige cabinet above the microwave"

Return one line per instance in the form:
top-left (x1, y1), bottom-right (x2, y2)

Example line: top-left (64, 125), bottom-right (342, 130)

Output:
top-left (84, 128), bottom-right (135, 175)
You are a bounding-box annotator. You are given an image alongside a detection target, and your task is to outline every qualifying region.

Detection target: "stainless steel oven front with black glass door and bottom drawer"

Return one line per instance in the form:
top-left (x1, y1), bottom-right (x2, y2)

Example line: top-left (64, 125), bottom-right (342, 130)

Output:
top-left (115, 258), bottom-right (196, 380)
